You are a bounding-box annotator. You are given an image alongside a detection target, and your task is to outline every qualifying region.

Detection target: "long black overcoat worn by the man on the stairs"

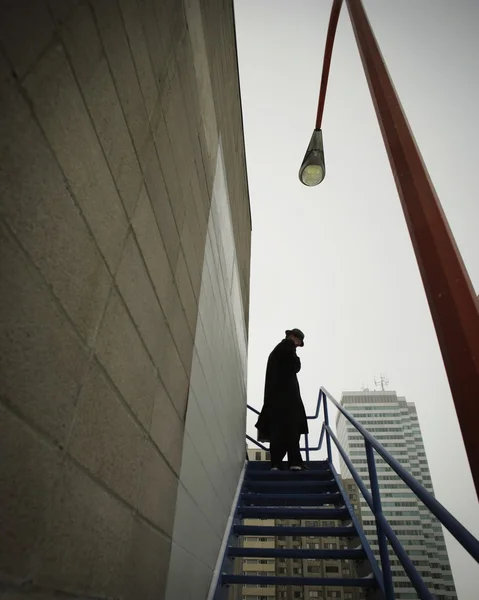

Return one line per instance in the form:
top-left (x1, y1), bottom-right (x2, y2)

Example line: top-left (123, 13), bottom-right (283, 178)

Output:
top-left (256, 338), bottom-right (308, 440)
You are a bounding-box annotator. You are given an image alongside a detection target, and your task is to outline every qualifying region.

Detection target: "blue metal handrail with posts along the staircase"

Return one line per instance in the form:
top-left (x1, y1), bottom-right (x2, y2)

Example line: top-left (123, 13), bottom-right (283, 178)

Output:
top-left (246, 387), bottom-right (479, 600)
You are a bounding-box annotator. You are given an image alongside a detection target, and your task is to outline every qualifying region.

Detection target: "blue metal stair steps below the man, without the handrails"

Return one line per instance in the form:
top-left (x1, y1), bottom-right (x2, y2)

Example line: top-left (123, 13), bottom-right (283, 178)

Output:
top-left (215, 461), bottom-right (381, 600)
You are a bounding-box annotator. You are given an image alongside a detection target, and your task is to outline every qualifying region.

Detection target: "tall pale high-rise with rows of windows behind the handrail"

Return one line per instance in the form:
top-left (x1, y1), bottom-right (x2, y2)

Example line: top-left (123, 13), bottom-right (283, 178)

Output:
top-left (337, 390), bottom-right (457, 600)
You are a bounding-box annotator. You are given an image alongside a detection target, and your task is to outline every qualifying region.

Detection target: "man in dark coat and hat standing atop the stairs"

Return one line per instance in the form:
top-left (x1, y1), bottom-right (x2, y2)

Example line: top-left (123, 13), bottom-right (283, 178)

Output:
top-left (256, 329), bottom-right (308, 471)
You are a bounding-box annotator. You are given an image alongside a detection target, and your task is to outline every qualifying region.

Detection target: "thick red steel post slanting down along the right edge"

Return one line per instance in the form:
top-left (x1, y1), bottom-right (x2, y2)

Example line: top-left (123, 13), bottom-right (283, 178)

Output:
top-left (346, 0), bottom-right (479, 496)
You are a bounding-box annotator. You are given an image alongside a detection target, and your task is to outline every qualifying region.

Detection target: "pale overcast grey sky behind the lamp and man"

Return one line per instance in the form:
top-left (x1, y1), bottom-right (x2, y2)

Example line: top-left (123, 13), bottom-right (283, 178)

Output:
top-left (235, 0), bottom-right (479, 600)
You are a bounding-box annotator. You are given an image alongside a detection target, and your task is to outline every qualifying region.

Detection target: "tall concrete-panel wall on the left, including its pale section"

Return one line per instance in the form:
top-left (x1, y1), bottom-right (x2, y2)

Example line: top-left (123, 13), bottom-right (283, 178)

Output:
top-left (0, 0), bottom-right (250, 600)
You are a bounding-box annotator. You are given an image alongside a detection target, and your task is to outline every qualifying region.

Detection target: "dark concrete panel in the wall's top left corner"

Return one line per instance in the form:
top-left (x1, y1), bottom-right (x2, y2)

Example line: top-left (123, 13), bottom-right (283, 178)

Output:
top-left (0, 0), bottom-right (54, 79)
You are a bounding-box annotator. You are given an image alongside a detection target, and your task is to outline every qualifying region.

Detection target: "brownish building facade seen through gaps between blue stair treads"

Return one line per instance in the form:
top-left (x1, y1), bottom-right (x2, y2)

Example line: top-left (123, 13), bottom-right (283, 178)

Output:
top-left (234, 448), bottom-right (364, 600)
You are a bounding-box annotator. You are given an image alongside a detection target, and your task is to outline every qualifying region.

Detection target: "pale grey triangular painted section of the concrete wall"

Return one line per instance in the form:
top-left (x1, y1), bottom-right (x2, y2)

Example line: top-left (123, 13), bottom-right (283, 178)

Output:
top-left (166, 139), bottom-right (246, 600)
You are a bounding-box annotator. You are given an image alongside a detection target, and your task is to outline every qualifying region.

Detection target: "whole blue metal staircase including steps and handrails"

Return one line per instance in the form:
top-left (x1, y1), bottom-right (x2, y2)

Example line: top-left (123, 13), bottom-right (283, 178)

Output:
top-left (208, 388), bottom-right (479, 600)
